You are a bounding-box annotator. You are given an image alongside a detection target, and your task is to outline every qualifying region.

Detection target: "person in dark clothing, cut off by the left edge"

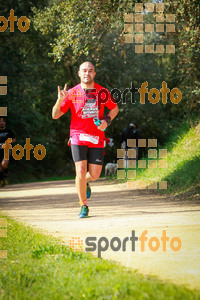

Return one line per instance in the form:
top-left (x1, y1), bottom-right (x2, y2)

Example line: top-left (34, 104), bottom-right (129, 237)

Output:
top-left (0, 117), bottom-right (16, 187)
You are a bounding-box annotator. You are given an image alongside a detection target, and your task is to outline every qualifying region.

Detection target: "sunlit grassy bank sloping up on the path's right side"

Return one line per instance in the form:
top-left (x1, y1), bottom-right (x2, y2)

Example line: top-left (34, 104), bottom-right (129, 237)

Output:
top-left (128, 124), bottom-right (200, 196)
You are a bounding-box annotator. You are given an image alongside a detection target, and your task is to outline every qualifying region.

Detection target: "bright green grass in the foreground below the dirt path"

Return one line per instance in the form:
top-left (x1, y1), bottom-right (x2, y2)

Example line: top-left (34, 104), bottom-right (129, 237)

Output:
top-left (0, 215), bottom-right (200, 300)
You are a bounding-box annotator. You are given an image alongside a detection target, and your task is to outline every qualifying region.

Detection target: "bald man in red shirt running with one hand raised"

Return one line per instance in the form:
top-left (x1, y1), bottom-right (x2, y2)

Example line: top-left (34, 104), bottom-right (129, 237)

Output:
top-left (52, 62), bottom-right (118, 218)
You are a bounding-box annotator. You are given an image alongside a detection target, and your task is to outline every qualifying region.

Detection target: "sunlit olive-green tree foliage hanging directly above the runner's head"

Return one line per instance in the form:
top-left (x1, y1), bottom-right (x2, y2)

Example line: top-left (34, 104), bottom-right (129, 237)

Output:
top-left (33, 0), bottom-right (126, 64)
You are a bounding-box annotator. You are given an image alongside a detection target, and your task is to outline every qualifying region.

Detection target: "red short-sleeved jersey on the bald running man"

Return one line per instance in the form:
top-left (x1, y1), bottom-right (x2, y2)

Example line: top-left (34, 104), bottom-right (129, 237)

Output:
top-left (61, 83), bottom-right (117, 137)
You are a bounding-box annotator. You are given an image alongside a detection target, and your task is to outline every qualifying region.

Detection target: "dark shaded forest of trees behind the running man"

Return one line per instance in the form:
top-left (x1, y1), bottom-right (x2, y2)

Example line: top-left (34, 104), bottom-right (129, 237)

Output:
top-left (0, 0), bottom-right (200, 182)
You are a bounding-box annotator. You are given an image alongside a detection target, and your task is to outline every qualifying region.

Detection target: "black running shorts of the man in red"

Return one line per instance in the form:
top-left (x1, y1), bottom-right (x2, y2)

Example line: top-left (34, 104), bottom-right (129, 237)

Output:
top-left (71, 145), bottom-right (104, 165)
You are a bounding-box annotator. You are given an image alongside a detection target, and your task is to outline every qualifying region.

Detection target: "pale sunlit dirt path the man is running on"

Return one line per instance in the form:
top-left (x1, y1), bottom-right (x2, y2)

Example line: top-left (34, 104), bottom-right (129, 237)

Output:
top-left (0, 179), bottom-right (200, 289)
